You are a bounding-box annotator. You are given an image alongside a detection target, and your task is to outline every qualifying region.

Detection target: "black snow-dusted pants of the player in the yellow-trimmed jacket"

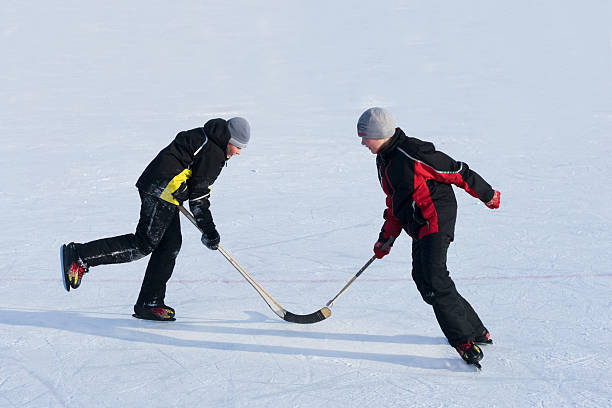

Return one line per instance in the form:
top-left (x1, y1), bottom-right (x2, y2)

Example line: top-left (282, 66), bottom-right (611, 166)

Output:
top-left (77, 191), bottom-right (182, 306)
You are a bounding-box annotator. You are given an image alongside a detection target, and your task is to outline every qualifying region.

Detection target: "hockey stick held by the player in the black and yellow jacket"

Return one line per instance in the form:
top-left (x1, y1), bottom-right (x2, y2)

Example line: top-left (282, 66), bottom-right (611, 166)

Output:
top-left (178, 204), bottom-right (331, 324)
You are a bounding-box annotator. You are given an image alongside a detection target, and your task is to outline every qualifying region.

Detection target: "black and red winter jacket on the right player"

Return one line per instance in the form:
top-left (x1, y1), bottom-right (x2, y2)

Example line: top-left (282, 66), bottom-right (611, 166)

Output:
top-left (376, 128), bottom-right (494, 239)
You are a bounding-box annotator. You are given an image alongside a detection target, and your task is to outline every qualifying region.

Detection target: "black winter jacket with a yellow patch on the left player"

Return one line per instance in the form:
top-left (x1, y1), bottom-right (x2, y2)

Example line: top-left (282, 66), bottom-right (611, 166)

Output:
top-left (136, 119), bottom-right (230, 231)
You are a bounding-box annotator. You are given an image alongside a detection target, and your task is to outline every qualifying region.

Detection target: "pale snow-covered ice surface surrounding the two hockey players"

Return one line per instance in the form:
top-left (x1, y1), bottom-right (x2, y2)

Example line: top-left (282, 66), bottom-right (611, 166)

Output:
top-left (0, 0), bottom-right (612, 407)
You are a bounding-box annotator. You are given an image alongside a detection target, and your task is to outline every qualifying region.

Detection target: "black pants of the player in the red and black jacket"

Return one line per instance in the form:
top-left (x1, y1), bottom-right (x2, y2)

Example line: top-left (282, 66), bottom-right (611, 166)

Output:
top-left (412, 232), bottom-right (484, 347)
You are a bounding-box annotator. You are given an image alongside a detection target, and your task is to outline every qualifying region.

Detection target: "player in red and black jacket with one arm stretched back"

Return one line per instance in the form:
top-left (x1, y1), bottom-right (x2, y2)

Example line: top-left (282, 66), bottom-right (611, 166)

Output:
top-left (357, 108), bottom-right (500, 365)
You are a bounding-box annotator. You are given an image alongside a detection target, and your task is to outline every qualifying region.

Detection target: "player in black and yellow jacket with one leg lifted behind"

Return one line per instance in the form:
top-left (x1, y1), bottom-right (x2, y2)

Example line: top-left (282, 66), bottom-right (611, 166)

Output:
top-left (60, 117), bottom-right (250, 320)
